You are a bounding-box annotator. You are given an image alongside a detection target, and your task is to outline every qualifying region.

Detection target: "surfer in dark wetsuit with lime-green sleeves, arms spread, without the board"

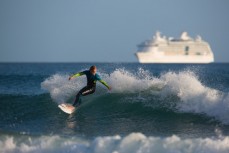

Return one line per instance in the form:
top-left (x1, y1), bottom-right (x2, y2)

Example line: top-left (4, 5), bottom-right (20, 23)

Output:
top-left (69, 65), bottom-right (111, 107)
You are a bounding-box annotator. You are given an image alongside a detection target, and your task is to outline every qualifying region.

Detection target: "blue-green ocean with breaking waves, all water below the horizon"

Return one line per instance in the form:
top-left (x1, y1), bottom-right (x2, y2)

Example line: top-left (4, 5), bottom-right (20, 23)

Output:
top-left (0, 63), bottom-right (229, 153)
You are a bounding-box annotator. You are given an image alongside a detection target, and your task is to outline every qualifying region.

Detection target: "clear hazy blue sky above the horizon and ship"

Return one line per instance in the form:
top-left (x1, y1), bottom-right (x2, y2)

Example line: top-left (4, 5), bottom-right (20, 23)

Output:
top-left (0, 0), bottom-right (229, 62)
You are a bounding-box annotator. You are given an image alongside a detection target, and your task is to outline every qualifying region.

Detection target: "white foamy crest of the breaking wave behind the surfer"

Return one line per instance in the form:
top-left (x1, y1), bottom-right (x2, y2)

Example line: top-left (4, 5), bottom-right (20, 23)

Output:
top-left (41, 69), bottom-right (229, 124)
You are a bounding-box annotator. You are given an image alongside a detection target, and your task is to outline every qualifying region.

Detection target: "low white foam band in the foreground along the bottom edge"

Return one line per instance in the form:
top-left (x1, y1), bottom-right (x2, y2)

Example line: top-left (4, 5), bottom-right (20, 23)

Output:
top-left (0, 133), bottom-right (229, 153)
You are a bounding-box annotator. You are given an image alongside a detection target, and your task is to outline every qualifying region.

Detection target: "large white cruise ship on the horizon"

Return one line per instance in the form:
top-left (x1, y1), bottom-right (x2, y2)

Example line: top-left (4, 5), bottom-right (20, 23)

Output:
top-left (135, 32), bottom-right (214, 63)
